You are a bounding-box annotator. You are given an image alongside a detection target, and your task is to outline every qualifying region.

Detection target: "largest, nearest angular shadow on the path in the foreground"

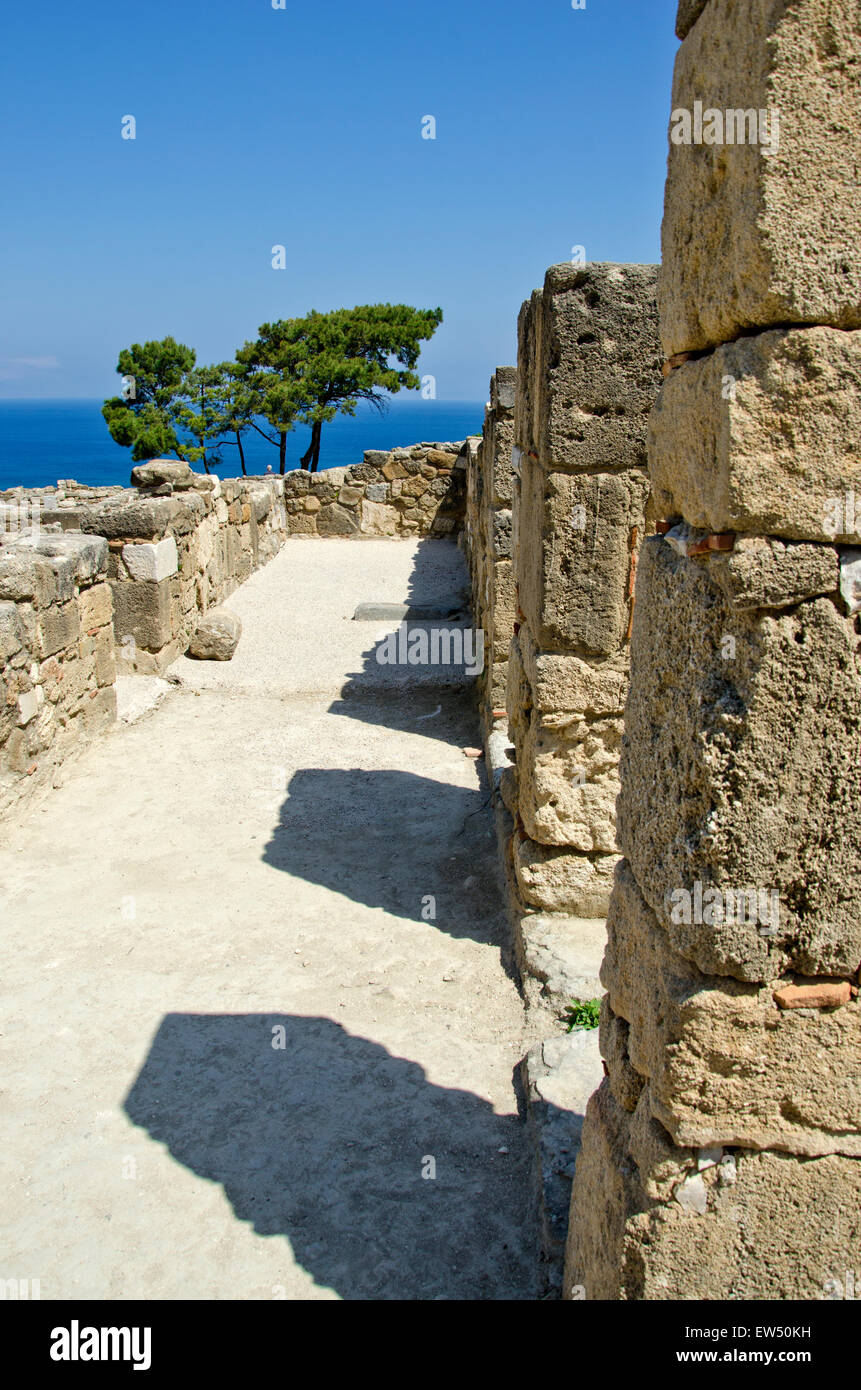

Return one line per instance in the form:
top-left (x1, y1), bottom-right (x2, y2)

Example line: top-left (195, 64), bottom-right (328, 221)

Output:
top-left (125, 1013), bottom-right (536, 1300)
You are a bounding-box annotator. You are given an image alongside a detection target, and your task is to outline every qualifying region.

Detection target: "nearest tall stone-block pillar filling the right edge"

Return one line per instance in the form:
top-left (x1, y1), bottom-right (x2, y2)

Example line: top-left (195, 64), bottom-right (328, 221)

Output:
top-left (566, 0), bottom-right (861, 1300)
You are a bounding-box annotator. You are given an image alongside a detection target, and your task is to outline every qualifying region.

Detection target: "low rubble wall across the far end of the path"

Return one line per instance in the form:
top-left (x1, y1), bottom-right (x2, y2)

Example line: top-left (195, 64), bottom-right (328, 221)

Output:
top-left (284, 441), bottom-right (466, 537)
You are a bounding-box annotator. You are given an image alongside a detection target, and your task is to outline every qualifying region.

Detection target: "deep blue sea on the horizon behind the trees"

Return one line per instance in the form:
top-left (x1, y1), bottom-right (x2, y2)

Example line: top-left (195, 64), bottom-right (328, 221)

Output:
top-left (0, 398), bottom-right (484, 488)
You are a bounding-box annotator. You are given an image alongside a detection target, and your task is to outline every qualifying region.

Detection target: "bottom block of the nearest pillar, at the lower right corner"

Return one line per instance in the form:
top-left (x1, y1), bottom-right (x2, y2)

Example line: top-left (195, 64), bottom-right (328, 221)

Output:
top-left (565, 1078), bottom-right (861, 1301)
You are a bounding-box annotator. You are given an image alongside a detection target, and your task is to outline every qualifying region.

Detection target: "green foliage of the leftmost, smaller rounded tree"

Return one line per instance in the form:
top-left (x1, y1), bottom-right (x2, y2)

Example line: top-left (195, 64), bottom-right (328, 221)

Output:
top-left (102, 338), bottom-right (195, 463)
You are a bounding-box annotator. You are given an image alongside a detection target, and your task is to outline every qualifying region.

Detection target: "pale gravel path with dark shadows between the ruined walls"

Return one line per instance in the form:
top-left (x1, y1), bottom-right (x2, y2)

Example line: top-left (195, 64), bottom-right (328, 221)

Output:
top-left (0, 539), bottom-right (537, 1300)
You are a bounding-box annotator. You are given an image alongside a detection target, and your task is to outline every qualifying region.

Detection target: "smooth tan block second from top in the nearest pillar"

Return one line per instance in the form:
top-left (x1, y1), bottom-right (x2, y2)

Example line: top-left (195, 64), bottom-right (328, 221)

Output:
top-left (650, 328), bottom-right (861, 541)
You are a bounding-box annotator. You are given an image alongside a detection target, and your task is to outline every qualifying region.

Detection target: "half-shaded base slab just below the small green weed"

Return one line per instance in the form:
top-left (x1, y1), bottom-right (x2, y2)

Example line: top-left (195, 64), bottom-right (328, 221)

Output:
top-left (520, 1029), bottom-right (604, 1290)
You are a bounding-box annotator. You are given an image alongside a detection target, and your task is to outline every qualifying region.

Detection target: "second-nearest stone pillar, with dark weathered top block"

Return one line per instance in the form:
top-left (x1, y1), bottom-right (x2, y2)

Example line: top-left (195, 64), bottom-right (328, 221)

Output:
top-left (506, 264), bottom-right (661, 1002)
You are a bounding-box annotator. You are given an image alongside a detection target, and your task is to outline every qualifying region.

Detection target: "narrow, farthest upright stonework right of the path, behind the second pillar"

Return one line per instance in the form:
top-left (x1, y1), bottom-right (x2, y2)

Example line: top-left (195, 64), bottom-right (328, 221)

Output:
top-left (463, 367), bottom-right (517, 728)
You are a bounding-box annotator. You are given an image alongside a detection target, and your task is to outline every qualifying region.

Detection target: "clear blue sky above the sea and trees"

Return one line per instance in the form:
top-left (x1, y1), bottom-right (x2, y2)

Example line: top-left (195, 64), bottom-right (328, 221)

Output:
top-left (0, 0), bottom-right (677, 400)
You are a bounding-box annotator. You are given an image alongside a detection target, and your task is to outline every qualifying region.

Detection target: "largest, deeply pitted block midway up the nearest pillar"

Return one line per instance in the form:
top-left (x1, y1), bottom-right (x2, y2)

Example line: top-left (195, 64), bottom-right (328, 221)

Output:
top-left (618, 538), bottom-right (861, 981)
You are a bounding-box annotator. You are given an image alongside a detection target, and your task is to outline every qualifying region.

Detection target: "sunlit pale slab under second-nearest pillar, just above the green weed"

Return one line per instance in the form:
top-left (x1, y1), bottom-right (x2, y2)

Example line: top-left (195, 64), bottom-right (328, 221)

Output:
top-left (516, 913), bottom-right (606, 1013)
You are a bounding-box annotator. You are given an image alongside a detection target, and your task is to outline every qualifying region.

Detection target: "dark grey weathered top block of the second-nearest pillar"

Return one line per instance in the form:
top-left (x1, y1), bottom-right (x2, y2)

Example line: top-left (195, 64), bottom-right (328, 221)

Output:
top-left (515, 263), bottom-right (661, 473)
